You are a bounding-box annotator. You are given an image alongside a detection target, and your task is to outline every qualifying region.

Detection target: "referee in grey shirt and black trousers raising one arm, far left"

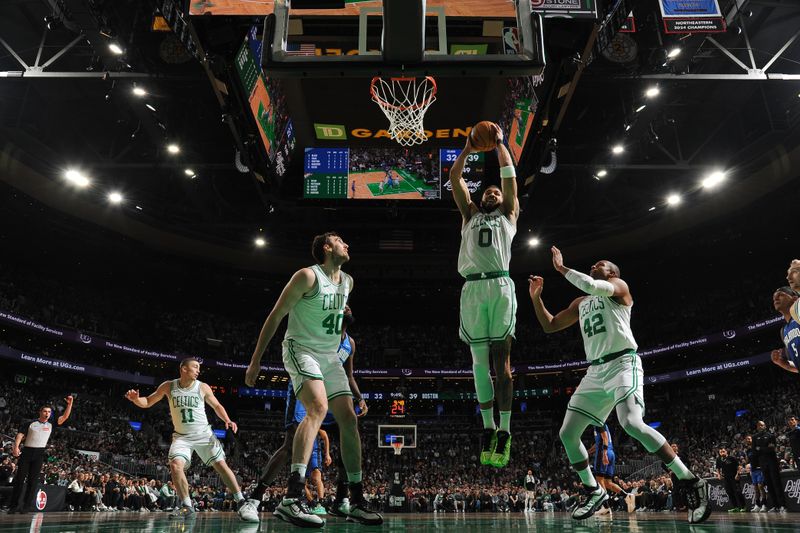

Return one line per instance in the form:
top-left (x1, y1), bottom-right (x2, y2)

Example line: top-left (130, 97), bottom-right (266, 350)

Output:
top-left (8, 396), bottom-right (72, 514)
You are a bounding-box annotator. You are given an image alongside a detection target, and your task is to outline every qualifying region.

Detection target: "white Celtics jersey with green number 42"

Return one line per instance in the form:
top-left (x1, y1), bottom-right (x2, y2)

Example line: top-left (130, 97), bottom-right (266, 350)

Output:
top-left (578, 296), bottom-right (638, 361)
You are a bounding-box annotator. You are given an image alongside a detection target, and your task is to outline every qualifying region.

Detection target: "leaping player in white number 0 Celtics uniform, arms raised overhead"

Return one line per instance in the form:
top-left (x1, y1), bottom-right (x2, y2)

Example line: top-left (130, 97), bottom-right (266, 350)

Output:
top-left (450, 124), bottom-right (519, 468)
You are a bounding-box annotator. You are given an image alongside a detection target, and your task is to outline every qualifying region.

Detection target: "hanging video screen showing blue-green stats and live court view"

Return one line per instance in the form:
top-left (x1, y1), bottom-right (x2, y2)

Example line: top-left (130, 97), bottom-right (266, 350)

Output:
top-left (303, 147), bottom-right (442, 200)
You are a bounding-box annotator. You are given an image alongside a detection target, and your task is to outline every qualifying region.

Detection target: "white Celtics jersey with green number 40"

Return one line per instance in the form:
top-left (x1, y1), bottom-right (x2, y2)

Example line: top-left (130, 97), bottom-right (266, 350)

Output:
top-left (283, 265), bottom-right (353, 354)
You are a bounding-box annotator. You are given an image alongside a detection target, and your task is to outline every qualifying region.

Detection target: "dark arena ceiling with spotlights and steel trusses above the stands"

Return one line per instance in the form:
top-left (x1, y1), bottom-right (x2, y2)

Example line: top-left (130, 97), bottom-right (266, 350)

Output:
top-left (0, 0), bottom-right (800, 270)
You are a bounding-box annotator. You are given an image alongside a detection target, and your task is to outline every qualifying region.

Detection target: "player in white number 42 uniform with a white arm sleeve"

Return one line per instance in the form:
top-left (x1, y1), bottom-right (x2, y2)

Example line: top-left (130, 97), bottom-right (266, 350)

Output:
top-left (529, 246), bottom-right (711, 523)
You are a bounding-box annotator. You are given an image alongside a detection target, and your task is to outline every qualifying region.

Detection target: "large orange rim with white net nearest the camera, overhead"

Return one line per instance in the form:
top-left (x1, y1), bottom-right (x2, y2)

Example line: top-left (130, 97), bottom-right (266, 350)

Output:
top-left (369, 76), bottom-right (436, 145)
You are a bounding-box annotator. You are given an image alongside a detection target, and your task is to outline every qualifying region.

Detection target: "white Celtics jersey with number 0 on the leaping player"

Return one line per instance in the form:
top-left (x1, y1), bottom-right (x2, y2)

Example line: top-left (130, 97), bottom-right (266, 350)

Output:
top-left (458, 209), bottom-right (517, 277)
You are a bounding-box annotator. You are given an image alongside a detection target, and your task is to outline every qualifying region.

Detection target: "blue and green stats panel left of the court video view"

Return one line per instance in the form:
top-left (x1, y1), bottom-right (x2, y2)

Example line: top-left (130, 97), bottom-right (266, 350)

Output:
top-left (303, 148), bottom-right (350, 198)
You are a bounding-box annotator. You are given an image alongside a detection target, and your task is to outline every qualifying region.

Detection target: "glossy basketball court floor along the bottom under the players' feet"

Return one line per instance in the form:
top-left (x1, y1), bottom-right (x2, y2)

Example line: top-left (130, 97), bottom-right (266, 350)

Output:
top-left (0, 513), bottom-right (800, 533)
